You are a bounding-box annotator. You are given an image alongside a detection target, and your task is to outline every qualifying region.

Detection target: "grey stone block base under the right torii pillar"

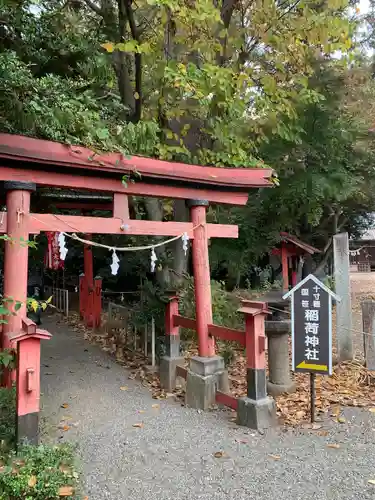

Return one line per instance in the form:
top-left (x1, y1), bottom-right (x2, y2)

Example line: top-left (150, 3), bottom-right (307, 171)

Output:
top-left (185, 356), bottom-right (226, 410)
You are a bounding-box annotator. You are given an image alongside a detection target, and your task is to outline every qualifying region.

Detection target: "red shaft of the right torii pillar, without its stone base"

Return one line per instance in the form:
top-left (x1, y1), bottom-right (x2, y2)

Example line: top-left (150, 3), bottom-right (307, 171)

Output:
top-left (188, 200), bottom-right (215, 356)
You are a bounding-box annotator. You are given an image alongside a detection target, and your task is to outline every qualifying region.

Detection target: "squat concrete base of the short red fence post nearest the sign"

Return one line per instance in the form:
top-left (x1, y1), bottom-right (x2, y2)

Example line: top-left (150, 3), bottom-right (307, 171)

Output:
top-left (237, 397), bottom-right (276, 430)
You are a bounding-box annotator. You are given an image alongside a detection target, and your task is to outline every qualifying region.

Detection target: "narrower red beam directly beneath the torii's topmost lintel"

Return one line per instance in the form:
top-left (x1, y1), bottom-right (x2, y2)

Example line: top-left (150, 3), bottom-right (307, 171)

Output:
top-left (0, 166), bottom-right (248, 205)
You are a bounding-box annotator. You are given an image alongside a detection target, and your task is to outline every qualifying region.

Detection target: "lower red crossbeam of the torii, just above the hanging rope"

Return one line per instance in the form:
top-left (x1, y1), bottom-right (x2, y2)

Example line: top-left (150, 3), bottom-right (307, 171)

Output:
top-left (0, 213), bottom-right (238, 239)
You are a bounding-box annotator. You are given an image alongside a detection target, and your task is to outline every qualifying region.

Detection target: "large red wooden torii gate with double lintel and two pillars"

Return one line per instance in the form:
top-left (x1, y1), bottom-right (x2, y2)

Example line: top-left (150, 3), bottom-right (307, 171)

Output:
top-left (0, 134), bottom-right (273, 439)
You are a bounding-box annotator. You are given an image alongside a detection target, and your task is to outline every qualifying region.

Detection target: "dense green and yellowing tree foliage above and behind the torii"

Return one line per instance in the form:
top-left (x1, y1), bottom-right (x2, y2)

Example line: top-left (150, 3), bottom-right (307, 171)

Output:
top-left (0, 0), bottom-right (374, 285)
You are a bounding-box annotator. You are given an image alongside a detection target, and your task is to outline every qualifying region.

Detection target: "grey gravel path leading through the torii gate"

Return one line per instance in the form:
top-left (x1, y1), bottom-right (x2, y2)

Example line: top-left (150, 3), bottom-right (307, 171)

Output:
top-left (41, 319), bottom-right (375, 500)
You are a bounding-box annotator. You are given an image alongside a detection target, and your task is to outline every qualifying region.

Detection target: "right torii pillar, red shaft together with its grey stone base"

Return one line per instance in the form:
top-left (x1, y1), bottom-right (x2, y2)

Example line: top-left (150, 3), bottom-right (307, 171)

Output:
top-left (186, 200), bottom-right (228, 410)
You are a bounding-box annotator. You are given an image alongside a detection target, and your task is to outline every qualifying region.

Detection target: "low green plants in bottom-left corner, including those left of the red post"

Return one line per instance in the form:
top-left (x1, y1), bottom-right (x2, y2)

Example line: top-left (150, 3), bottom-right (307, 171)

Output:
top-left (0, 388), bottom-right (82, 500)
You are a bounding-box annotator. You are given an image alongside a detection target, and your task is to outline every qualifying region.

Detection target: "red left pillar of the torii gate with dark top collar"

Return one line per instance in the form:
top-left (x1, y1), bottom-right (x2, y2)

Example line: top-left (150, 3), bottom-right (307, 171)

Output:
top-left (2, 181), bottom-right (36, 387)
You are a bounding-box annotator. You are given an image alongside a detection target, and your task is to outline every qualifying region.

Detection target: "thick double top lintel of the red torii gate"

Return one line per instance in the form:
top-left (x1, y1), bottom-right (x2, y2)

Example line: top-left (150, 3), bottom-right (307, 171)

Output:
top-left (0, 134), bottom-right (273, 205)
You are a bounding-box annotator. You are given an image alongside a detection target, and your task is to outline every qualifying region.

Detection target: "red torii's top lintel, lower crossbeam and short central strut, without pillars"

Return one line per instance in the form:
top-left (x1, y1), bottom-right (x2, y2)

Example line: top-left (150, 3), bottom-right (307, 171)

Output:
top-left (0, 134), bottom-right (273, 238)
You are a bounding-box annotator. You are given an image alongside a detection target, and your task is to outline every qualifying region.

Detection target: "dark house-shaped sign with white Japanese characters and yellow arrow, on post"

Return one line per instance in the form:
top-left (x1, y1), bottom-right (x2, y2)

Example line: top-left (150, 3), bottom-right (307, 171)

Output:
top-left (283, 274), bottom-right (340, 422)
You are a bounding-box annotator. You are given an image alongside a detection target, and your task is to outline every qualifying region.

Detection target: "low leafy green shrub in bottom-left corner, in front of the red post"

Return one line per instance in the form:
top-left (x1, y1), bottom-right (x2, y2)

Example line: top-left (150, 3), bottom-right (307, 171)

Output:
top-left (0, 445), bottom-right (79, 500)
